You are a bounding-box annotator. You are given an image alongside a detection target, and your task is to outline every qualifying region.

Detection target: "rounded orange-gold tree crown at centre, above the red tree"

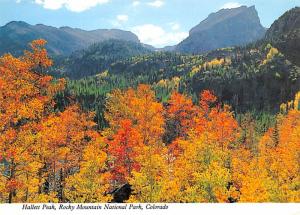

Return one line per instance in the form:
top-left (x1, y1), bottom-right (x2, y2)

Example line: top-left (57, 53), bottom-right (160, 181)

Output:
top-left (105, 85), bottom-right (164, 145)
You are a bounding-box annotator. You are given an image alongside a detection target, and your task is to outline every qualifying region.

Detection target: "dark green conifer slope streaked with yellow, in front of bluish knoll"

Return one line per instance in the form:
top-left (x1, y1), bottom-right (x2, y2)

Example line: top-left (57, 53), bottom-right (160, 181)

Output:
top-left (61, 43), bottom-right (300, 127)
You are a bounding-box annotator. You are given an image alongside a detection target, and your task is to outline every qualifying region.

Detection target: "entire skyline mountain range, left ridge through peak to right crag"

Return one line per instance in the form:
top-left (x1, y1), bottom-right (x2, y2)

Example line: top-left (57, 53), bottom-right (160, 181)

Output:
top-left (0, 6), bottom-right (300, 59)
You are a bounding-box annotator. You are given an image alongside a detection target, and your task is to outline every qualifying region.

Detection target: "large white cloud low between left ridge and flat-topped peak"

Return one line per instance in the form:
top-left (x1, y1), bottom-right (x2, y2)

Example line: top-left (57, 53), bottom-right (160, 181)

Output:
top-left (131, 24), bottom-right (188, 47)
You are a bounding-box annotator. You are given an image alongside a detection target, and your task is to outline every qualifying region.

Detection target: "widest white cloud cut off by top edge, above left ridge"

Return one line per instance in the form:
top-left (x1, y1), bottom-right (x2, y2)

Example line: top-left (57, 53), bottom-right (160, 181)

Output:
top-left (35, 0), bottom-right (110, 12)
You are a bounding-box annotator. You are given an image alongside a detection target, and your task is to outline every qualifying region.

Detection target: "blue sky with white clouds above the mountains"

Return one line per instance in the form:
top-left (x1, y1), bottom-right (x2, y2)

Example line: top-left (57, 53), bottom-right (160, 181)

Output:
top-left (0, 0), bottom-right (300, 47)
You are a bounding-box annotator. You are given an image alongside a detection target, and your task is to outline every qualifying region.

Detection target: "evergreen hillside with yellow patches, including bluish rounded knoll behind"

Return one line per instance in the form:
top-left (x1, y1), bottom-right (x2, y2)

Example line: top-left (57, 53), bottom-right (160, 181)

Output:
top-left (55, 8), bottom-right (300, 131)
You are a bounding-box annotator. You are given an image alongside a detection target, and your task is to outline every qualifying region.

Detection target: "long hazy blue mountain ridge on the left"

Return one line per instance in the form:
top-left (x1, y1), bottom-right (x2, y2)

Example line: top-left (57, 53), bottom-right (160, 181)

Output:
top-left (0, 21), bottom-right (140, 55)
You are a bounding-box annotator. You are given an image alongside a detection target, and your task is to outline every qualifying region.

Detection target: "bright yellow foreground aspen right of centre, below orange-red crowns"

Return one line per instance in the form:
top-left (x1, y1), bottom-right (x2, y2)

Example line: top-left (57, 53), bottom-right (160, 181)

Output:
top-left (166, 133), bottom-right (230, 202)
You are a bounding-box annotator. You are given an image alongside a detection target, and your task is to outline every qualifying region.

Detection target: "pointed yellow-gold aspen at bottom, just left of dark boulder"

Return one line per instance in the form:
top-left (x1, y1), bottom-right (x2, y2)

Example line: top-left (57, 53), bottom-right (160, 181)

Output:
top-left (65, 139), bottom-right (111, 203)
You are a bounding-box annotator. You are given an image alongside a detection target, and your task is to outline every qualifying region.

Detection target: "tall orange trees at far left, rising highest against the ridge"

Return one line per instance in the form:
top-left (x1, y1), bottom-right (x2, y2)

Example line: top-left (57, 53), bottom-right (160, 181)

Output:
top-left (0, 40), bottom-right (108, 203)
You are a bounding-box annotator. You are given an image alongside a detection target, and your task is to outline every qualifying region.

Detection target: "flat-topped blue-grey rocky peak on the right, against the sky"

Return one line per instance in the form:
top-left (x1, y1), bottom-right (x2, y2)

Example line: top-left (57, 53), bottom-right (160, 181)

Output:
top-left (175, 6), bottom-right (266, 53)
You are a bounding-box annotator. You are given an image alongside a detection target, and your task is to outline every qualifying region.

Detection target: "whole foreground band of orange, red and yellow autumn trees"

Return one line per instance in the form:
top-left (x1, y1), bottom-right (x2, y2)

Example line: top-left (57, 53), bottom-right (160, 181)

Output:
top-left (0, 40), bottom-right (300, 203)
